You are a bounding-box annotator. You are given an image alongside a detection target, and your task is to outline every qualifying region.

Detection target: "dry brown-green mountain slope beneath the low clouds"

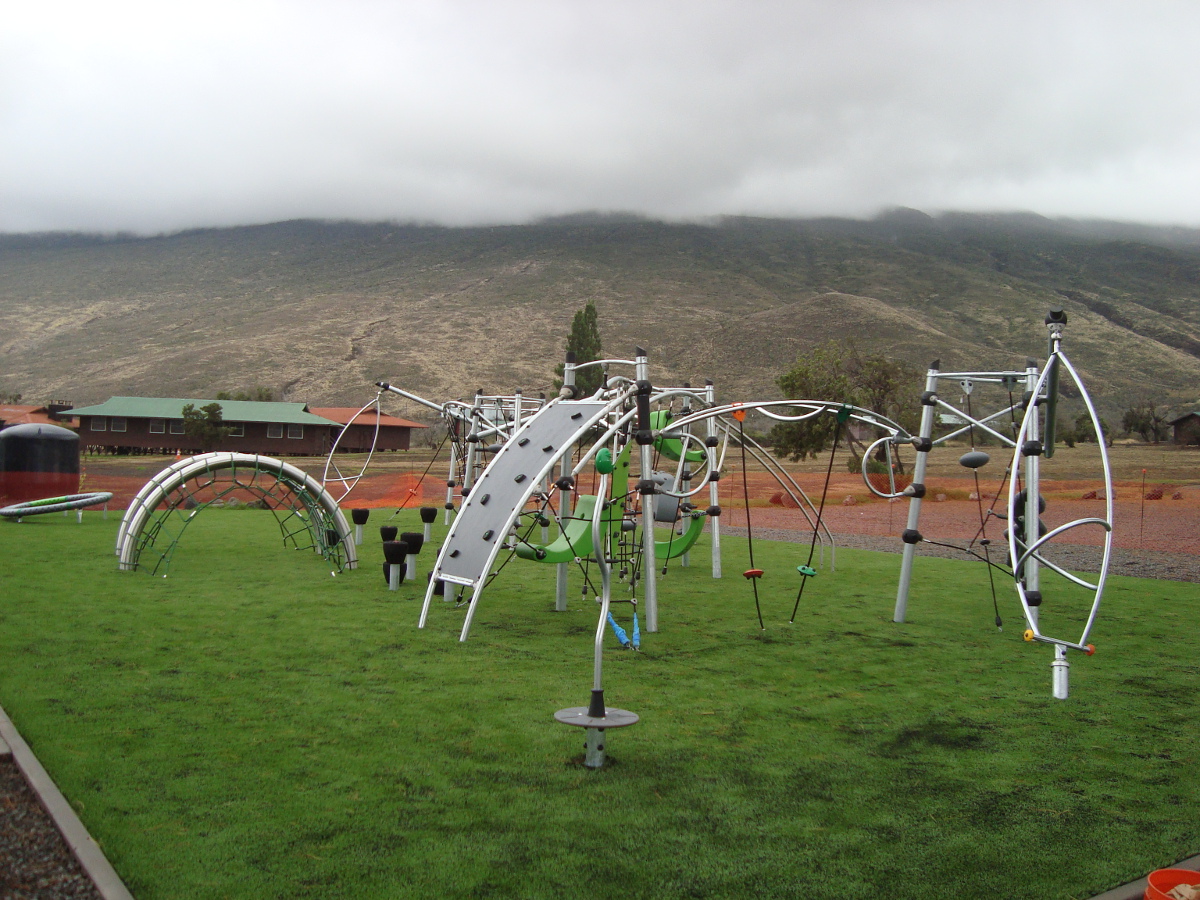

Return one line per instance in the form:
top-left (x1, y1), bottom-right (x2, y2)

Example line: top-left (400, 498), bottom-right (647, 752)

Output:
top-left (0, 211), bottom-right (1200, 418)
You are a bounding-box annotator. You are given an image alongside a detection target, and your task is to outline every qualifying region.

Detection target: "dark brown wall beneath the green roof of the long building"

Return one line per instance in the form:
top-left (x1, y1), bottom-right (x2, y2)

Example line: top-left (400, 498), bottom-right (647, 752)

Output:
top-left (79, 415), bottom-right (336, 456)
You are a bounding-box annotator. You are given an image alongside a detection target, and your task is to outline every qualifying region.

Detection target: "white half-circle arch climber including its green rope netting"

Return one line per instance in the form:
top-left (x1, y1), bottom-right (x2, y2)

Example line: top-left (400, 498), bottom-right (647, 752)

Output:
top-left (116, 452), bottom-right (358, 577)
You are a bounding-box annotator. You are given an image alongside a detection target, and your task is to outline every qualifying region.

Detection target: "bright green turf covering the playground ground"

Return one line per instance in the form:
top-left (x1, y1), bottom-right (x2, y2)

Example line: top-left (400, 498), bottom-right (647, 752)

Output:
top-left (0, 510), bottom-right (1200, 900)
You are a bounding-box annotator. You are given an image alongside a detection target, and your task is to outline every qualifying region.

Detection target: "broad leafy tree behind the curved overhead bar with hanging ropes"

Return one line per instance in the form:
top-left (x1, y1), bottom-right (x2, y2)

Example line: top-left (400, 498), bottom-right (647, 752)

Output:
top-left (770, 342), bottom-right (922, 461)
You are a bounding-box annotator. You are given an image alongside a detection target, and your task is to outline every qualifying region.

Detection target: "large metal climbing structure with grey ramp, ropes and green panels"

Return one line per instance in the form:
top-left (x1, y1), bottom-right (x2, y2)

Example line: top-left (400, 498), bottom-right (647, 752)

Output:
top-left (312, 310), bottom-right (1112, 766)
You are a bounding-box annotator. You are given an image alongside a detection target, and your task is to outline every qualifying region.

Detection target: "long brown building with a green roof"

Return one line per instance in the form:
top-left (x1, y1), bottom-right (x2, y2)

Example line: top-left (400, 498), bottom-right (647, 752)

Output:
top-left (62, 397), bottom-right (355, 456)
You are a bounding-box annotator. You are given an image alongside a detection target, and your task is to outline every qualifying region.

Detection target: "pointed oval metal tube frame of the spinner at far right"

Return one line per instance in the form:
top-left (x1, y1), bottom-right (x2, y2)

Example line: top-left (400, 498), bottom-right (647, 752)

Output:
top-left (1008, 348), bottom-right (1114, 653)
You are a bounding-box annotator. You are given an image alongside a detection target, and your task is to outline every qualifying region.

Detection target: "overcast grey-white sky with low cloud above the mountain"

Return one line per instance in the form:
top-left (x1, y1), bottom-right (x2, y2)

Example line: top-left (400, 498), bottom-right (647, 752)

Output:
top-left (0, 0), bottom-right (1200, 233)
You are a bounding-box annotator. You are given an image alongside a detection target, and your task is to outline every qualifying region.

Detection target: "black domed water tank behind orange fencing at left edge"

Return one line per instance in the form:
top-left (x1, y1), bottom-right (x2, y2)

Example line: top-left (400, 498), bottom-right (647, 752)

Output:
top-left (0, 424), bottom-right (79, 506)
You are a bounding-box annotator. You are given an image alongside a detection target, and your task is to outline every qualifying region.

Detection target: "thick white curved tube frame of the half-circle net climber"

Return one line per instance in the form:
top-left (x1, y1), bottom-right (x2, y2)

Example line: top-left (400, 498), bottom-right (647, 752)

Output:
top-left (118, 452), bottom-right (358, 571)
